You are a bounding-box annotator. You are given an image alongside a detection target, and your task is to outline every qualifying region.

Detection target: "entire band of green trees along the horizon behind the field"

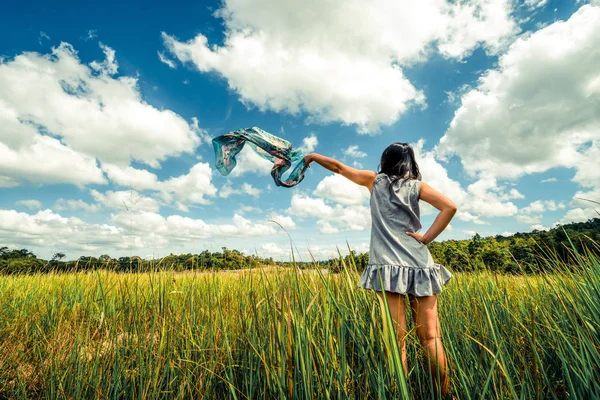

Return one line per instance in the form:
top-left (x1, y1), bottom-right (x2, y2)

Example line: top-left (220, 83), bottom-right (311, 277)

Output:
top-left (0, 218), bottom-right (600, 274)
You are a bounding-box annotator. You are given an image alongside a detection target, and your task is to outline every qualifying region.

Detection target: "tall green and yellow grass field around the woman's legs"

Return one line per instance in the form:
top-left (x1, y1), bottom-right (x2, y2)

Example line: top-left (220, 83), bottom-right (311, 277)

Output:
top-left (0, 252), bottom-right (600, 399)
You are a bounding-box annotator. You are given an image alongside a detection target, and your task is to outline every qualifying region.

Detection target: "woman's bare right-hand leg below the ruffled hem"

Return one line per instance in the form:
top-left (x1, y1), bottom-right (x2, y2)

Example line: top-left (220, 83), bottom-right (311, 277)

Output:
top-left (409, 294), bottom-right (450, 395)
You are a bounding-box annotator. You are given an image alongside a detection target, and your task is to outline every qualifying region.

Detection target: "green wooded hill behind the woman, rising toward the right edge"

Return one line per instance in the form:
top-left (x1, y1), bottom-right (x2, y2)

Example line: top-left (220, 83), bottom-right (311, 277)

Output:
top-left (328, 218), bottom-right (600, 274)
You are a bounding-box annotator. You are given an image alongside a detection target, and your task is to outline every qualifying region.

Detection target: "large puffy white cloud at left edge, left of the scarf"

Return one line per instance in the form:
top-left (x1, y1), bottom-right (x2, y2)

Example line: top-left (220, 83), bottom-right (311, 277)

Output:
top-left (0, 43), bottom-right (202, 186)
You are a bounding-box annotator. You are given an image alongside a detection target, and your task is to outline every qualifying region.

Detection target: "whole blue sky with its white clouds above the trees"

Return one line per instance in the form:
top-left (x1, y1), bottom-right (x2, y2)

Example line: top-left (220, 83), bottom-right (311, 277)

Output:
top-left (0, 0), bottom-right (600, 259)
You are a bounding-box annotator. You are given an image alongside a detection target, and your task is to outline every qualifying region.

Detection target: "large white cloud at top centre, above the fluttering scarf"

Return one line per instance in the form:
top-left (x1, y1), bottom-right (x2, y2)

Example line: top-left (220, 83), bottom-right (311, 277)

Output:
top-left (163, 0), bottom-right (517, 133)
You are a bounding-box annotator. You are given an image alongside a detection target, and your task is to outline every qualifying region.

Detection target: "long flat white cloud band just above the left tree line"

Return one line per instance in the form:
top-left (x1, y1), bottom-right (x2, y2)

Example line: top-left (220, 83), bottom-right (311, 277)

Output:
top-left (0, 209), bottom-right (276, 257)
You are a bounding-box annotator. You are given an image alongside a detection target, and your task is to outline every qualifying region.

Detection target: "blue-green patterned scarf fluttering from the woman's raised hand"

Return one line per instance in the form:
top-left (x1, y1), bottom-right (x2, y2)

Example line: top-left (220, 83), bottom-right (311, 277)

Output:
top-left (212, 127), bottom-right (308, 187)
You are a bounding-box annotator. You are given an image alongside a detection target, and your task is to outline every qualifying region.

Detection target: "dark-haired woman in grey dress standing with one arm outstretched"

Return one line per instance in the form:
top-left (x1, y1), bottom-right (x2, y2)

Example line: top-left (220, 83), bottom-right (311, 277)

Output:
top-left (305, 143), bottom-right (456, 395)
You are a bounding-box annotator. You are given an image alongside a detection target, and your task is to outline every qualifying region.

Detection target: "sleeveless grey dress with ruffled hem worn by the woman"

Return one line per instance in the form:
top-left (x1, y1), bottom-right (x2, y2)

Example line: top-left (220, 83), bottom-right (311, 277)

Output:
top-left (359, 174), bottom-right (452, 296)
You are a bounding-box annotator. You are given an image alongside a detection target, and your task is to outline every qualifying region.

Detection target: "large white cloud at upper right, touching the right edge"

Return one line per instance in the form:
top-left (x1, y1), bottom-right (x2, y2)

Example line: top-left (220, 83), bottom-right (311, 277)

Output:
top-left (437, 5), bottom-right (600, 186)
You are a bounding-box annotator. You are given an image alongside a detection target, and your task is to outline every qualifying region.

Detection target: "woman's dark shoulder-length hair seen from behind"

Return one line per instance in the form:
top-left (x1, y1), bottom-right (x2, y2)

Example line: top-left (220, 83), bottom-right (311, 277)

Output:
top-left (378, 142), bottom-right (421, 183)
